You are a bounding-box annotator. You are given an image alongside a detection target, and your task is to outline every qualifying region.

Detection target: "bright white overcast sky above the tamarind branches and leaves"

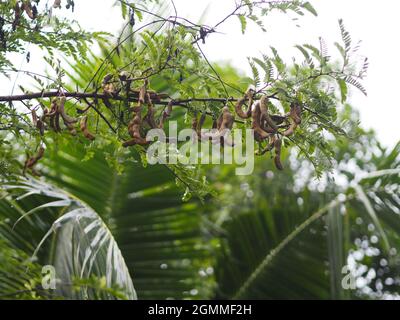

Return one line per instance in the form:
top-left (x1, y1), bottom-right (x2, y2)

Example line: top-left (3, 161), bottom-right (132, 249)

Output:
top-left (3, 0), bottom-right (400, 146)
